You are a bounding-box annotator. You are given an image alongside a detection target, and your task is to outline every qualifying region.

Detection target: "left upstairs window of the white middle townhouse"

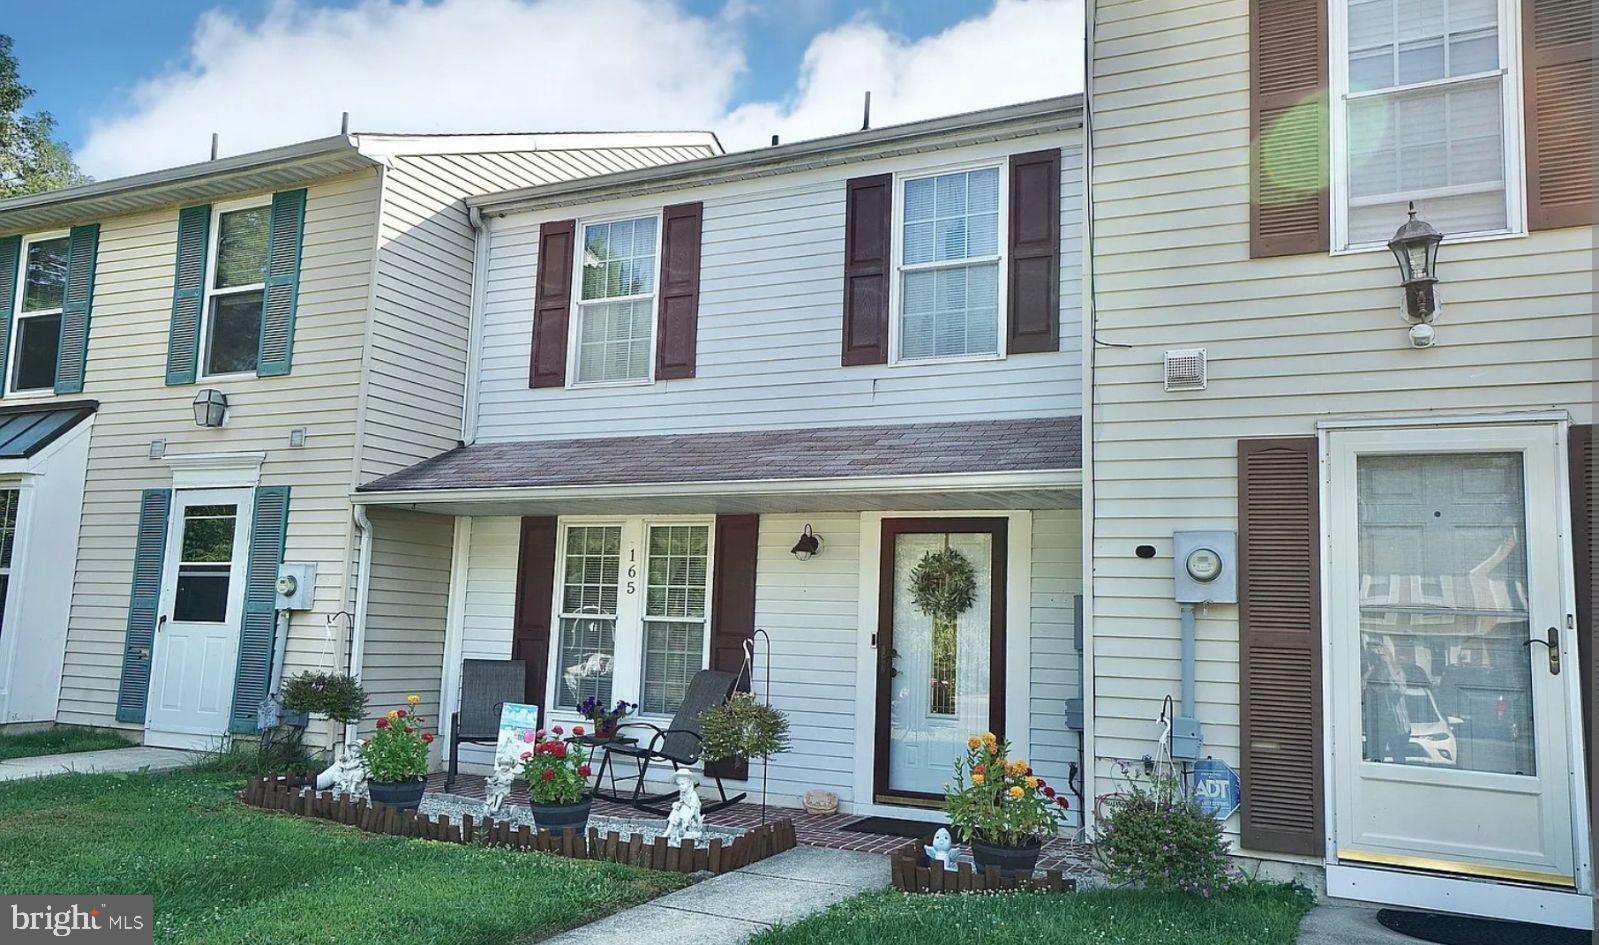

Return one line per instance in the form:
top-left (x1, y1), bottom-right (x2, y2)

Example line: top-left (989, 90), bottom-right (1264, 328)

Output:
top-left (572, 216), bottom-right (660, 384)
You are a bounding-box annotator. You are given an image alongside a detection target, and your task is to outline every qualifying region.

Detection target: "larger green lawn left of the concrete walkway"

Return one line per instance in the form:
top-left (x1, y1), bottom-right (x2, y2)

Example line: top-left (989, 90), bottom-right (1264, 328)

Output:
top-left (0, 772), bottom-right (686, 945)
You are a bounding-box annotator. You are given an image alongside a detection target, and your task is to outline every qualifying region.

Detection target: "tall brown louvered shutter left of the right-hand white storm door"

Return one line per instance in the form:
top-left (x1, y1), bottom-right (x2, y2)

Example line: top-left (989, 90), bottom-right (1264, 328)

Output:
top-left (1238, 437), bottom-right (1322, 855)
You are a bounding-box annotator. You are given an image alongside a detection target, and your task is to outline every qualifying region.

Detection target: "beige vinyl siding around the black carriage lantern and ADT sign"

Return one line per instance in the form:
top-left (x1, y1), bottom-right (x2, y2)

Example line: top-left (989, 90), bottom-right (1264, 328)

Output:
top-left (1092, 0), bottom-right (1594, 850)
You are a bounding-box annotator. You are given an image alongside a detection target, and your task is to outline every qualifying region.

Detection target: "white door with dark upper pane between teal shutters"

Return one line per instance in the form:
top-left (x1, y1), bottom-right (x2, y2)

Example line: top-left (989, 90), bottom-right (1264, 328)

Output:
top-left (144, 489), bottom-right (254, 748)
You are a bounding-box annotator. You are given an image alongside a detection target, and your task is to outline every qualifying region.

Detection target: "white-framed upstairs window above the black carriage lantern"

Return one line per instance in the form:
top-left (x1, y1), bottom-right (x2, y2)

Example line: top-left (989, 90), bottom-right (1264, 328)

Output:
top-left (1334, 0), bottom-right (1522, 246)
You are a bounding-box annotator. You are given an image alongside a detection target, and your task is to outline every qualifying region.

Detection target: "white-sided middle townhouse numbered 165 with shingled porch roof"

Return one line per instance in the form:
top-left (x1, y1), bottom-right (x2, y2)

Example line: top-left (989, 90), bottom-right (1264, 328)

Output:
top-left (355, 98), bottom-right (1083, 817)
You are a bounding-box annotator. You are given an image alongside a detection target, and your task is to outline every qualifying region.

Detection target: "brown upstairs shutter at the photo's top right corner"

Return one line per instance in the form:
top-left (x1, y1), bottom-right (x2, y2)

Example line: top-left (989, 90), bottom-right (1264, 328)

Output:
top-left (1521, 0), bottom-right (1599, 230)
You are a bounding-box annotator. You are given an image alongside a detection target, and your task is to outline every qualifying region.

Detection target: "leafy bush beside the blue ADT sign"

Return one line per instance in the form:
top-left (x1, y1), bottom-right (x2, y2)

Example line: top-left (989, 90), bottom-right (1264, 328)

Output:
top-left (1094, 764), bottom-right (1238, 897)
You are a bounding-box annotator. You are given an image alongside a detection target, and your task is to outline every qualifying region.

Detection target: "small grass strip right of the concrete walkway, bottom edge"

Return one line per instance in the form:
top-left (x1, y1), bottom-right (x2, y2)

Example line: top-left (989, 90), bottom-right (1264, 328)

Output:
top-left (750, 883), bottom-right (1311, 945)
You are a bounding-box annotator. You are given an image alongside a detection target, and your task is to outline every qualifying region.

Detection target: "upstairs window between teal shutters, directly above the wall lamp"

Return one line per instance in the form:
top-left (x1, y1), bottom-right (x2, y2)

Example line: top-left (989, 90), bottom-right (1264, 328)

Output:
top-left (200, 203), bottom-right (272, 377)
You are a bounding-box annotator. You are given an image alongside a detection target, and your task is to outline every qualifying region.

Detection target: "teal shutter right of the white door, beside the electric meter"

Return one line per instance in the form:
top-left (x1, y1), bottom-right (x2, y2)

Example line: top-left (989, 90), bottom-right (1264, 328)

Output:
top-left (229, 486), bottom-right (289, 732)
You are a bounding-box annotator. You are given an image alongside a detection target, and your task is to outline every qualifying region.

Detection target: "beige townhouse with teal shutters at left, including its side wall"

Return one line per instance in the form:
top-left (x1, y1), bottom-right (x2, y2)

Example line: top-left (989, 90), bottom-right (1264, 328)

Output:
top-left (0, 134), bottom-right (721, 747)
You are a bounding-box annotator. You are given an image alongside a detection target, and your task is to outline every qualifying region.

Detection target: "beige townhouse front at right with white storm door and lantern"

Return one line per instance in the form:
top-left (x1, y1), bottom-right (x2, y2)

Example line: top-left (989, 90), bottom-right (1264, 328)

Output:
top-left (1084, 0), bottom-right (1596, 927)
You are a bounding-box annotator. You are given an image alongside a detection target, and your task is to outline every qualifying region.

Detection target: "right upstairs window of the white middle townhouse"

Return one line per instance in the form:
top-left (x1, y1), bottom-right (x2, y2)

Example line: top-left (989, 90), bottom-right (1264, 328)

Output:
top-left (897, 166), bottom-right (1004, 361)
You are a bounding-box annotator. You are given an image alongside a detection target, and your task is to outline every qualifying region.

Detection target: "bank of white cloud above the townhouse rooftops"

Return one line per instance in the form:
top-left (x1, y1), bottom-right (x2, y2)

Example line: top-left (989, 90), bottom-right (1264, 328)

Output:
top-left (78, 0), bottom-right (1083, 179)
